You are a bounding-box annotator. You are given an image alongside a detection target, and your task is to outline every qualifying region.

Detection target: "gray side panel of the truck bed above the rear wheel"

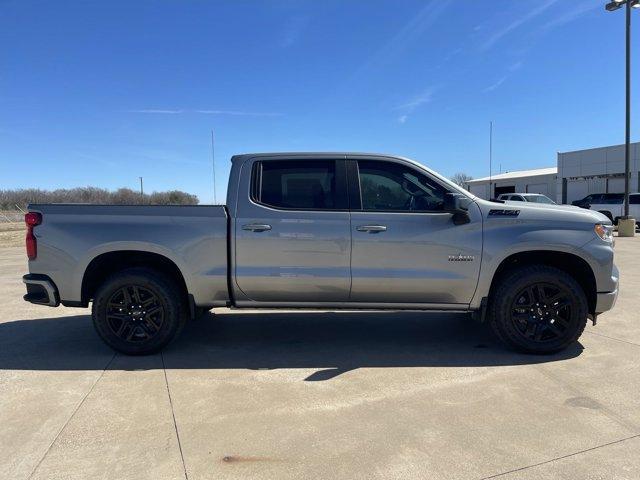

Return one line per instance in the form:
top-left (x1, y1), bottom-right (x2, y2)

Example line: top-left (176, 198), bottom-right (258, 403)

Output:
top-left (29, 204), bottom-right (229, 306)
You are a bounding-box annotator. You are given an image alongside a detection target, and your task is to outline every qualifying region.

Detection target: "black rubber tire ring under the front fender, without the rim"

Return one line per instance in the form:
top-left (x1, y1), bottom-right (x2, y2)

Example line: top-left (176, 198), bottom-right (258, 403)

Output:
top-left (490, 266), bottom-right (588, 354)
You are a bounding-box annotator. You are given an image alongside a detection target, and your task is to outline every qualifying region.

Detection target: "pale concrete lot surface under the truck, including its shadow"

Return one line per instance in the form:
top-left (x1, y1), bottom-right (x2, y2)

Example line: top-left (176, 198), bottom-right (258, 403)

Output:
top-left (0, 237), bottom-right (640, 480)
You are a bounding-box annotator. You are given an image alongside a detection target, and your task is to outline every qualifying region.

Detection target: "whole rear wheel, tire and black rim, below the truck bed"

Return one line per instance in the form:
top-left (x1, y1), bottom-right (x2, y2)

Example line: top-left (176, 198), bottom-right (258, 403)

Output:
top-left (91, 268), bottom-right (187, 355)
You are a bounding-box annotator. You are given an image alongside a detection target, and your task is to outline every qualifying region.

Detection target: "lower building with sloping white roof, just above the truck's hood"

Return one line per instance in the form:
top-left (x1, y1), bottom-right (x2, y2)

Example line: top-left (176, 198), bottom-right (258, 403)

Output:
top-left (466, 167), bottom-right (558, 200)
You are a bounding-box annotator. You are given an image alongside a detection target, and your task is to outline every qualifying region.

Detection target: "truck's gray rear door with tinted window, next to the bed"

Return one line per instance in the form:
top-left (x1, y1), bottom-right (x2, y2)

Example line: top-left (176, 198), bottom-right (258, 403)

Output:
top-left (234, 156), bottom-right (351, 304)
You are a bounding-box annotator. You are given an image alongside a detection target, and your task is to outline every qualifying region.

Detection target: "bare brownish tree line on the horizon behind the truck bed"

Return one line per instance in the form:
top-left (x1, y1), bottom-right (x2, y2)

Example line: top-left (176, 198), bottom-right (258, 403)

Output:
top-left (0, 187), bottom-right (198, 210)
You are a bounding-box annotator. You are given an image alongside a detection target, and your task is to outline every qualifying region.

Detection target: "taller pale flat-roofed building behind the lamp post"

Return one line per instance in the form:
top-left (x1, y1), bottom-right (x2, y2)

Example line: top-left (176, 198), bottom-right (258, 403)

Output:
top-left (557, 143), bottom-right (640, 203)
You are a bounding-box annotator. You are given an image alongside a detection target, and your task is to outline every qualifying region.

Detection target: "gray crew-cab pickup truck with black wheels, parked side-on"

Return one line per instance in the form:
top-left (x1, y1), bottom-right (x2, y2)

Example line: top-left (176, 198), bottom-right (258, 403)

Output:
top-left (24, 153), bottom-right (618, 354)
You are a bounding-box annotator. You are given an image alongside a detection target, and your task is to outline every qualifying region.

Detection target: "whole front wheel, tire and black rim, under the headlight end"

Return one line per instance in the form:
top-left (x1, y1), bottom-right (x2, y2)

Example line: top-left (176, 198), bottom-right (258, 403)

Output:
top-left (488, 265), bottom-right (588, 354)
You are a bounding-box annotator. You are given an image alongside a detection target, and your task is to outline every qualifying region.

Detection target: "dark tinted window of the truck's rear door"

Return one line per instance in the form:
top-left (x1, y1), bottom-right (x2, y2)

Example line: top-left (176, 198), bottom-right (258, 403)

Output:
top-left (252, 160), bottom-right (343, 210)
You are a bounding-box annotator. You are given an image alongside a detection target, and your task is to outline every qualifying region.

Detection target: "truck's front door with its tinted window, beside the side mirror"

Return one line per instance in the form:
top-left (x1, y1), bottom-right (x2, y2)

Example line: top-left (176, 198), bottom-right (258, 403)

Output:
top-left (349, 158), bottom-right (482, 305)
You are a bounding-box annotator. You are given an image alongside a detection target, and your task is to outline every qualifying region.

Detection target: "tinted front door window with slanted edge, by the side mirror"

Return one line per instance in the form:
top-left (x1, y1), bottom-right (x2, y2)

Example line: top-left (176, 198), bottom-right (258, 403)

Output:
top-left (358, 160), bottom-right (447, 211)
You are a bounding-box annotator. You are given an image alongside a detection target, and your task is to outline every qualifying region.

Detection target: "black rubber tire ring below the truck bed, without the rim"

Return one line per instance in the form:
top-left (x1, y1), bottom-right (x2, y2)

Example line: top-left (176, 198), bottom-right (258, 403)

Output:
top-left (91, 268), bottom-right (184, 355)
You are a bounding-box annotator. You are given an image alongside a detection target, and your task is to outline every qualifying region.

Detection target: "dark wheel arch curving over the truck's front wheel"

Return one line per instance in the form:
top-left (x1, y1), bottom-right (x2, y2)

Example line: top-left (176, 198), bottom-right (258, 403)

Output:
top-left (488, 250), bottom-right (597, 314)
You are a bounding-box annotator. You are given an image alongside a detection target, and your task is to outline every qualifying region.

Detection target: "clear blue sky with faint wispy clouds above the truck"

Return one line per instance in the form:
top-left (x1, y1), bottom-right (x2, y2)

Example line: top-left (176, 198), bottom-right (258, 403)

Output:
top-left (0, 0), bottom-right (640, 203)
